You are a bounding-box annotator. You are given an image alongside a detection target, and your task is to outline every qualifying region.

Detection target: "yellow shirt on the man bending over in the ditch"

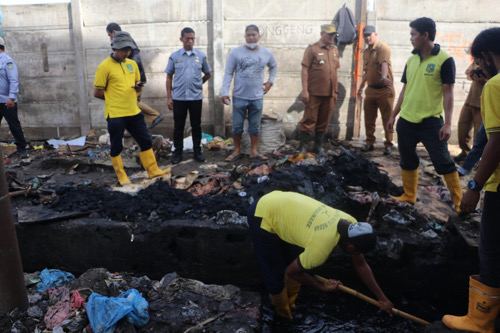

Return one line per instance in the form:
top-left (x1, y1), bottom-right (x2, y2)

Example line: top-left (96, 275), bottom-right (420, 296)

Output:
top-left (255, 191), bottom-right (357, 269)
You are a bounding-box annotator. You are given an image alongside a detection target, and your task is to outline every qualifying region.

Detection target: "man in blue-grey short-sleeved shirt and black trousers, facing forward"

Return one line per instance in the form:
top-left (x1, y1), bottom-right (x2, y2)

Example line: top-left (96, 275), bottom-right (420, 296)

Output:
top-left (165, 27), bottom-right (212, 164)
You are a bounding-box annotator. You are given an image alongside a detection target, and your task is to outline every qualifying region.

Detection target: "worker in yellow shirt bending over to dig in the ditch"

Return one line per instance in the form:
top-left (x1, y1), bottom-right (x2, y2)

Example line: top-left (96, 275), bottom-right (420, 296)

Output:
top-left (248, 191), bottom-right (393, 318)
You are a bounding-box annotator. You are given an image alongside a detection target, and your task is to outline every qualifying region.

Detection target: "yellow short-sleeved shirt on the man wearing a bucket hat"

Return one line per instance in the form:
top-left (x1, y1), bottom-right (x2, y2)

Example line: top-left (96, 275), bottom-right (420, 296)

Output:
top-left (94, 57), bottom-right (141, 118)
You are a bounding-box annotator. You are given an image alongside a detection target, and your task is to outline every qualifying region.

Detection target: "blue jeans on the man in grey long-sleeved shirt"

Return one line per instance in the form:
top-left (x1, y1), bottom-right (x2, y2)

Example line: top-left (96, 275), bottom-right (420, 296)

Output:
top-left (233, 97), bottom-right (264, 135)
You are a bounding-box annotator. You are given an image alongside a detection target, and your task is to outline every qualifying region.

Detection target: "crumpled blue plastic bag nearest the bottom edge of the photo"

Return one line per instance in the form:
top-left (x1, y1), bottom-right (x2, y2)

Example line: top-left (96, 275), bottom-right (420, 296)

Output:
top-left (86, 289), bottom-right (149, 333)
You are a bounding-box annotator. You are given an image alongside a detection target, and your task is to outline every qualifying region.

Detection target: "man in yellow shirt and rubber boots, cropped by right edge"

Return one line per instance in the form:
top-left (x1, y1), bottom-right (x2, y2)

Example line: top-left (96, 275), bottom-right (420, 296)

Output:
top-left (443, 28), bottom-right (500, 333)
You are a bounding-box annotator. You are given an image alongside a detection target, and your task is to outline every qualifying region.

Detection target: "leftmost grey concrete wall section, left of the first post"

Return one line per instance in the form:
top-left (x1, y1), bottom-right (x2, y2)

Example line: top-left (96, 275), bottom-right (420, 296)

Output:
top-left (0, 4), bottom-right (80, 141)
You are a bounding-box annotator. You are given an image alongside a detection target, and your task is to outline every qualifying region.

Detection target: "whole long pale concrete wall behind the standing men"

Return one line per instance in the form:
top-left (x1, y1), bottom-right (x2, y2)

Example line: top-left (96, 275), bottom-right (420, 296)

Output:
top-left (0, 0), bottom-right (498, 144)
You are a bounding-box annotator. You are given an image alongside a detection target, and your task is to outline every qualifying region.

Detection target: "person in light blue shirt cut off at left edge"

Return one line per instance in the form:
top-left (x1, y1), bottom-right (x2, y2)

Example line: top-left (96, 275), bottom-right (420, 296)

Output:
top-left (0, 37), bottom-right (28, 158)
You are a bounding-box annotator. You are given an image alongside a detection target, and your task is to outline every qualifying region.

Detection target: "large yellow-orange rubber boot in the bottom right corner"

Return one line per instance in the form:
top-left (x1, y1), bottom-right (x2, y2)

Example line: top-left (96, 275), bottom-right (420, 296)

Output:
top-left (442, 275), bottom-right (500, 333)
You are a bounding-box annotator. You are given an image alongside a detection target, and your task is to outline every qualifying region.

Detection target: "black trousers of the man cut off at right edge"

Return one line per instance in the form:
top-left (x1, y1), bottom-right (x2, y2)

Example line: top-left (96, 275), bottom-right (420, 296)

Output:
top-left (479, 186), bottom-right (500, 288)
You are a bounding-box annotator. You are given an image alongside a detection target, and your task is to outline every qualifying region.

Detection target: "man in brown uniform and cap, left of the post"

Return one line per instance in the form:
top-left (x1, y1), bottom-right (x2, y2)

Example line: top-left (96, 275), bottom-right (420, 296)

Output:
top-left (299, 24), bottom-right (340, 153)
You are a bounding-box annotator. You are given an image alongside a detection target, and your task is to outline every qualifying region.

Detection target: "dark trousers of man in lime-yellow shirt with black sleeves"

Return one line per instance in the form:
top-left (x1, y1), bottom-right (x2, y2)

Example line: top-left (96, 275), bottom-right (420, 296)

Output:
top-left (396, 117), bottom-right (457, 175)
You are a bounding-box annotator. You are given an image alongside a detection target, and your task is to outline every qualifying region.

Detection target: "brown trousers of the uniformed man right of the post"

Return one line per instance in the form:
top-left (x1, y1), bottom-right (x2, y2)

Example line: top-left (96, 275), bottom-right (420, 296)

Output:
top-left (363, 87), bottom-right (394, 147)
